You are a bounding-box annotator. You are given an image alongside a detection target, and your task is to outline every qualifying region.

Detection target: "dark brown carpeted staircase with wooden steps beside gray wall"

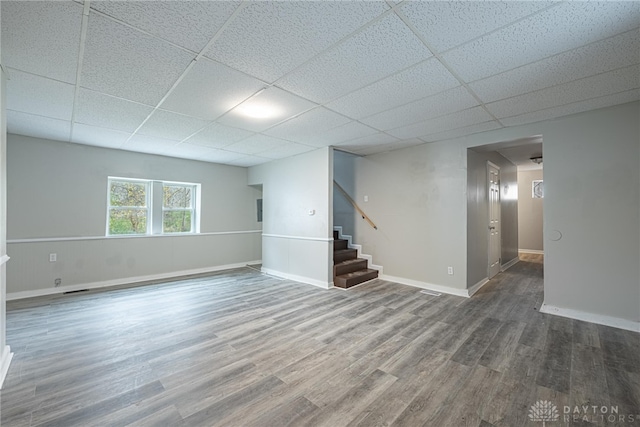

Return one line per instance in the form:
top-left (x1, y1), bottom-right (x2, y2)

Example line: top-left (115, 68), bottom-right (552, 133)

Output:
top-left (333, 231), bottom-right (378, 289)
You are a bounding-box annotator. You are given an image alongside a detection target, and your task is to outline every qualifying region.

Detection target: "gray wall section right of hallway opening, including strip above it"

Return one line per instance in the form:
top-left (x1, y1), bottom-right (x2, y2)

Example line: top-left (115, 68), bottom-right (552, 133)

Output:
top-left (462, 102), bottom-right (640, 330)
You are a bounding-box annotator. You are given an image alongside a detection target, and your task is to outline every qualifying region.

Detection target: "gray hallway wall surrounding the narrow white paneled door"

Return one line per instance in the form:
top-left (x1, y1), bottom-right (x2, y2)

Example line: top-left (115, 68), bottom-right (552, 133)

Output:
top-left (467, 150), bottom-right (518, 286)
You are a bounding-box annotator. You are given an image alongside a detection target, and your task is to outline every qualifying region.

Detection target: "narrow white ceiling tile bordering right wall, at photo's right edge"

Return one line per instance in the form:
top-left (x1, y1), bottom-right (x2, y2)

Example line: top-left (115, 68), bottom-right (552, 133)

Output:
top-left (501, 89), bottom-right (640, 126)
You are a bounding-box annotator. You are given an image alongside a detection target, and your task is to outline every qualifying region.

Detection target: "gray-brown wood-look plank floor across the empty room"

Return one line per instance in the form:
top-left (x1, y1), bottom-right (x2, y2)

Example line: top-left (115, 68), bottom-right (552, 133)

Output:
top-left (0, 257), bottom-right (640, 427)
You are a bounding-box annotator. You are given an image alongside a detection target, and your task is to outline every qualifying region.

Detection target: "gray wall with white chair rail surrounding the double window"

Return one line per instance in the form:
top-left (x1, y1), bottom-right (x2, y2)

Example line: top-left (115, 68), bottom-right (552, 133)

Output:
top-left (7, 135), bottom-right (261, 296)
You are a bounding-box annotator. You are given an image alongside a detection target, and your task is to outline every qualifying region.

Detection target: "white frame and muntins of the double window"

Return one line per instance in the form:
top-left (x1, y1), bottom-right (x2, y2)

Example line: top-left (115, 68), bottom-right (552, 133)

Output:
top-left (105, 176), bottom-right (201, 237)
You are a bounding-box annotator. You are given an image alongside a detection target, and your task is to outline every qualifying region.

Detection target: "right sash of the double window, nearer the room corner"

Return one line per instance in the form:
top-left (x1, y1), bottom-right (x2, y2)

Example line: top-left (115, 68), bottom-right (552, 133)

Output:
top-left (162, 183), bottom-right (196, 233)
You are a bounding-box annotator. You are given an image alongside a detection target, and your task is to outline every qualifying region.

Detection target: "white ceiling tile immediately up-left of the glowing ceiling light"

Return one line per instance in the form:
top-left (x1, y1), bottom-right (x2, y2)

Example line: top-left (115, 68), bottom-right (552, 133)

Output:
top-left (162, 58), bottom-right (265, 120)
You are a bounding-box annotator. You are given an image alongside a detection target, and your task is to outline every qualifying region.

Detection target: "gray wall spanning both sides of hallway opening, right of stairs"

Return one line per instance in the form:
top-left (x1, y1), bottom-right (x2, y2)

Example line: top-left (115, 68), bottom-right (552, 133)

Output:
top-left (342, 102), bottom-right (640, 329)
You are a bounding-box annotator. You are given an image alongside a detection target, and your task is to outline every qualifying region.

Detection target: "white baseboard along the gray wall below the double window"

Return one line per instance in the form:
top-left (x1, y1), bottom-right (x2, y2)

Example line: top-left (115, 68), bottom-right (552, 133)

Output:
top-left (7, 260), bottom-right (262, 301)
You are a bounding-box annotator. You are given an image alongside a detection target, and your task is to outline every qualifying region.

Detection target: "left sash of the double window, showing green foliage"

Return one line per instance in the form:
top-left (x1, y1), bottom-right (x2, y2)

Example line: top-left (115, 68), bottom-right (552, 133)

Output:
top-left (107, 179), bottom-right (150, 235)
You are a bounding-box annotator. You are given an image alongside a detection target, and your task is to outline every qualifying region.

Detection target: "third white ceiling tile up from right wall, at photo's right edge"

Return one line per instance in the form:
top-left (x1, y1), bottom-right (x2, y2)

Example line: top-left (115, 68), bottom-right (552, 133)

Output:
top-left (469, 30), bottom-right (640, 102)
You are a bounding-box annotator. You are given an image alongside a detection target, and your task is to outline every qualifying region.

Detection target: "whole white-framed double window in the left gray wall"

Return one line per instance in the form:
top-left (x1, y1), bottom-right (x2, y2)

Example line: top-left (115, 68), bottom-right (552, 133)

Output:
top-left (107, 177), bottom-right (200, 236)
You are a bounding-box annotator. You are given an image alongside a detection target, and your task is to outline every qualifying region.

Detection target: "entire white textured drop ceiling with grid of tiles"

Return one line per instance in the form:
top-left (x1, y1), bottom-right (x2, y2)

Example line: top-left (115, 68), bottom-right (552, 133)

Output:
top-left (1, 0), bottom-right (640, 166)
